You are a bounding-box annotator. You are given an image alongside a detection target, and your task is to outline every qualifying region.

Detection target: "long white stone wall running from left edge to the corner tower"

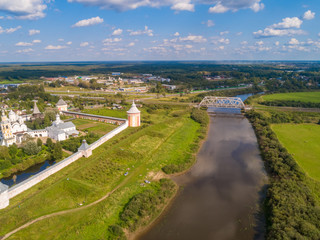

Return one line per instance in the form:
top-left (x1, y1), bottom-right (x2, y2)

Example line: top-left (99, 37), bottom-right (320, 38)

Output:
top-left (0, 119), bottom-right (128, 209)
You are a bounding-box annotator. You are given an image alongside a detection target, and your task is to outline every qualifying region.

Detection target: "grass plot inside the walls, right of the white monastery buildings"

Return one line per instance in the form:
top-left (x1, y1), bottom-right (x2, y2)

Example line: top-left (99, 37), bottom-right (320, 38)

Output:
top-left (72, 119), bottom-right (118, 135)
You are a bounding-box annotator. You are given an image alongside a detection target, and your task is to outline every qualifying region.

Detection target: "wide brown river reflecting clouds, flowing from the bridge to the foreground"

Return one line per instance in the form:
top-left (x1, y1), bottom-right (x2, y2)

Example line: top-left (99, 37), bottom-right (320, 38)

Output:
top-left (137, 94), bottom-right (267, 240)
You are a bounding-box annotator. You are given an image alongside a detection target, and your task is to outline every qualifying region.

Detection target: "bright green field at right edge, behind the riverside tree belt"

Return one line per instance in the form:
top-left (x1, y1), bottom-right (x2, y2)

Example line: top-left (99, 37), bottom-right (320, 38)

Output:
top-left (272, 124), bottom-right (320, 181)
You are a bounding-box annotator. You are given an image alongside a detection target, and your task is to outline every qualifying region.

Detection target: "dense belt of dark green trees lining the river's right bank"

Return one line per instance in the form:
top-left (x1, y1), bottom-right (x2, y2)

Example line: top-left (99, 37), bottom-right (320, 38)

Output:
top-left (246, 111), bottom-right (320, 240)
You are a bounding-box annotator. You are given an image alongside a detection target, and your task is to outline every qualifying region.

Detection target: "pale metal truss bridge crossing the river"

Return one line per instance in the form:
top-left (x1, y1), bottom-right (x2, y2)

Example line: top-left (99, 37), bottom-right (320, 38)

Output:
top-left (199, 96), bottom-right (246, 109)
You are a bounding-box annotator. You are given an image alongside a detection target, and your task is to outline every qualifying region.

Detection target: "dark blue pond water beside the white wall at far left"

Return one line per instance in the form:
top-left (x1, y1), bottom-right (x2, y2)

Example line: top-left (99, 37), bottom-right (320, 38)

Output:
top-left (0, 161), bottom-right (56, 187)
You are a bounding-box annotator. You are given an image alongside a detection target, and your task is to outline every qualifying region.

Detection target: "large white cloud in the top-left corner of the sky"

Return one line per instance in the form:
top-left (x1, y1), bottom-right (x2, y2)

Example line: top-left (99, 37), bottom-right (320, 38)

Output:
top-left (0, 0), bottom-right (48, 19)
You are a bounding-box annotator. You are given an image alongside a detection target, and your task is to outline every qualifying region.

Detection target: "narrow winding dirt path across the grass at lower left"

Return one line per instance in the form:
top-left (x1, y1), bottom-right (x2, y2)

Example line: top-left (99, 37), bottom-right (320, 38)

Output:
top-left (0, 178), bottom-right (130, 240)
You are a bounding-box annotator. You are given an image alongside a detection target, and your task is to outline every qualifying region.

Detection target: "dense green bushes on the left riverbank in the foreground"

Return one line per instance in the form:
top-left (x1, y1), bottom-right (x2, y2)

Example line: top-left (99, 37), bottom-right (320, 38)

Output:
top-left (114, 179), bottom-right (175, 232)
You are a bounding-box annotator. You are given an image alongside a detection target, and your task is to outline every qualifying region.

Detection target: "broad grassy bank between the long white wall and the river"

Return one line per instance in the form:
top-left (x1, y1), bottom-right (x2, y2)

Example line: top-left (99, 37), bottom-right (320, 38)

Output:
top-left (0, 106), bottom-right (208, 239)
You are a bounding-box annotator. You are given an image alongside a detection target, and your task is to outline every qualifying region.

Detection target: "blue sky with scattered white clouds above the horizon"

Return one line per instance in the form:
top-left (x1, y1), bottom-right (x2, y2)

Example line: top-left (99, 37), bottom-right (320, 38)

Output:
top-left (0, 0), bottom-right (320, 62)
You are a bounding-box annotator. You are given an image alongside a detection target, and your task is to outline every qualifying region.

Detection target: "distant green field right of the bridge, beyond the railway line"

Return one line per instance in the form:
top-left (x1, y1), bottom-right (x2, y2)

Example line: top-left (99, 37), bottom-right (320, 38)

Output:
top-left (262, 92), bottom-right (320, 103)
